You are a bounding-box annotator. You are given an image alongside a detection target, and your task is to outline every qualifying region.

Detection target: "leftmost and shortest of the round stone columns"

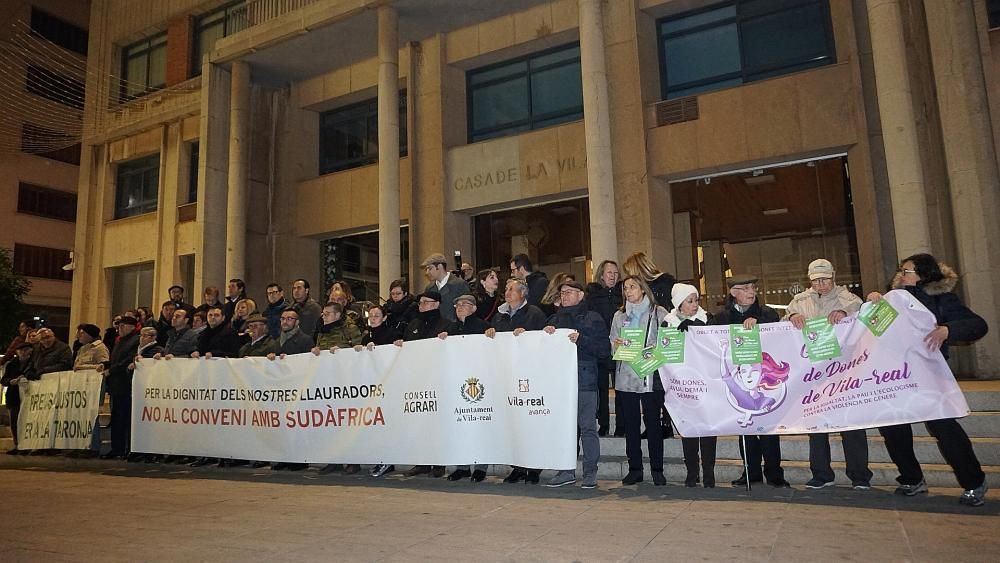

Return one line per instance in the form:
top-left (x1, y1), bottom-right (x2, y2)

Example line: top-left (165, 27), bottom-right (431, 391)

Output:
top-left (227, 61), bottom-right (250, 283)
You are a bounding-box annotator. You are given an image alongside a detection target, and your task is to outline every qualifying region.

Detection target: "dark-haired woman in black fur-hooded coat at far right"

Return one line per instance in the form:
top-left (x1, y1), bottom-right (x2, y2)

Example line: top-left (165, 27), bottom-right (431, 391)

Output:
top-left (868, 254), bottom-right (989, 506)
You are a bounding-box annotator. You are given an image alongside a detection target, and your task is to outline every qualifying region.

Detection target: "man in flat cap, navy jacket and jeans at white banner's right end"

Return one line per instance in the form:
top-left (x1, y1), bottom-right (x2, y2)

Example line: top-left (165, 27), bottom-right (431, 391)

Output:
top-left (542, 281), bottom-right (611, 489)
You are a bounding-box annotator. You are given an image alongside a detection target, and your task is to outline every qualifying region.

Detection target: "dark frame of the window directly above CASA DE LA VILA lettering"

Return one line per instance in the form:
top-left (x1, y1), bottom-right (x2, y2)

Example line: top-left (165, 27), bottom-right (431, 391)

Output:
top-left (465, 41), bottom-right (584, 143)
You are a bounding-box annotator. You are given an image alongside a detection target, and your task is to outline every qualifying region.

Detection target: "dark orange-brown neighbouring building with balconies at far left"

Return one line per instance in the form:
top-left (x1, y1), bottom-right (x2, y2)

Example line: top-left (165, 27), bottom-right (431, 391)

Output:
top-left (0, 0), bottom-right (90, 340)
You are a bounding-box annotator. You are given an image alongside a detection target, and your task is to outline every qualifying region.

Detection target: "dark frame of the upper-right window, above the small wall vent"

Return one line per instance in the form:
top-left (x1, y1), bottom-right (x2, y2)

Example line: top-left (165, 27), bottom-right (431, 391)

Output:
top-left (656, 0), bottom-right (837, 100)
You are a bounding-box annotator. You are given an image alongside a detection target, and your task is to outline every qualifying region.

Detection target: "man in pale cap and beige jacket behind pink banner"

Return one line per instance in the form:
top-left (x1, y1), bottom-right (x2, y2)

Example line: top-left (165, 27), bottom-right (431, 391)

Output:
top-left (784, 258), bottom-right (872, 491)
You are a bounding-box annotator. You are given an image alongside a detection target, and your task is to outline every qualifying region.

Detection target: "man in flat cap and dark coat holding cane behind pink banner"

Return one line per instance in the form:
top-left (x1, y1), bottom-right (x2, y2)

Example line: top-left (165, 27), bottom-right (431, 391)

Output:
top-left (711, 274), bottom-right (791, 488)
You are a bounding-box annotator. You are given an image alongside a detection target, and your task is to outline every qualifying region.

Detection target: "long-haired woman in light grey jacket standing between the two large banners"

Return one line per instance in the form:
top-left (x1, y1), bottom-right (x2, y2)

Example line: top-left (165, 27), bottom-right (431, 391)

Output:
top-left (610, 276), bottom-right (667, 486)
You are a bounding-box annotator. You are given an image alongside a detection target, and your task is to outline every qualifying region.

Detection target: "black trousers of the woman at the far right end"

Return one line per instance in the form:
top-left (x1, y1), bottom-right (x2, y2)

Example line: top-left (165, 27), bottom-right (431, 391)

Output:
top-left (878, 418), bottom-right (986, 490)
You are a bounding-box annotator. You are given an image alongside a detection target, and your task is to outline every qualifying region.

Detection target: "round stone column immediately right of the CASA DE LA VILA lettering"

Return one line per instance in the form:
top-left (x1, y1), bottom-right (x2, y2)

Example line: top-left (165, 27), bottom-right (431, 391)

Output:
top-left (579, 0), bottom-right (618, 263)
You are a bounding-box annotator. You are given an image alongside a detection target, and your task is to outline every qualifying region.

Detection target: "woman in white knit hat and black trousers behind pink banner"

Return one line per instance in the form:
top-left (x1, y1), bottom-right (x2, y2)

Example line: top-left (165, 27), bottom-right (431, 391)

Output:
top-left (661, 283), bottom-right (719, 489)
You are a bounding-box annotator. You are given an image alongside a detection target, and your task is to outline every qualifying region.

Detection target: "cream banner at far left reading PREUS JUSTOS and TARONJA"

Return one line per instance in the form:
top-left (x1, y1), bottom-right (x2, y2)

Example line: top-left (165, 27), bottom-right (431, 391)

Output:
top-left (17, 370), bottom-right (101, 450)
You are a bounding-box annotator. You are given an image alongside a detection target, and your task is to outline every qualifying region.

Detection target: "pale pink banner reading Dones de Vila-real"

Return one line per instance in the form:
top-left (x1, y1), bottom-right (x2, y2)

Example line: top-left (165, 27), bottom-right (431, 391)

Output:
top-left (660, 291), bottom-right (969, 437)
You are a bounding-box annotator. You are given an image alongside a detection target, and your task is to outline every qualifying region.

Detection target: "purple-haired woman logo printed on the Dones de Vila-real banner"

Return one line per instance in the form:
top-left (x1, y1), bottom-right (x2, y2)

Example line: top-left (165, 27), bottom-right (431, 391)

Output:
top-left (722, 352), bottom-right (789, 428)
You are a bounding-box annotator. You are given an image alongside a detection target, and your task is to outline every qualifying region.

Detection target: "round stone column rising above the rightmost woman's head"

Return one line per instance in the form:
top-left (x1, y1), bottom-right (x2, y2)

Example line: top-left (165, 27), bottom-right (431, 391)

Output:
top-left (868, 0), bottom-right (932, 258)
